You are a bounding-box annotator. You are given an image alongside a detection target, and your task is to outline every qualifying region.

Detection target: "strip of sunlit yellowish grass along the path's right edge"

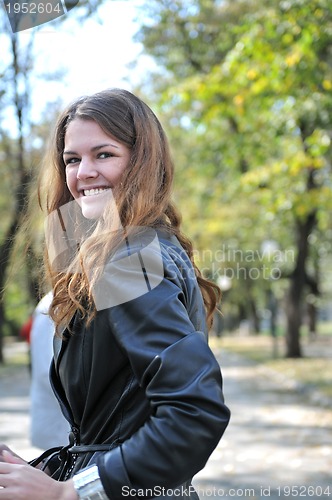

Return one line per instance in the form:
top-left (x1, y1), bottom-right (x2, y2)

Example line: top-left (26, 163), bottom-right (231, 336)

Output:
top-left (210, 335), bottom-right (332, 400)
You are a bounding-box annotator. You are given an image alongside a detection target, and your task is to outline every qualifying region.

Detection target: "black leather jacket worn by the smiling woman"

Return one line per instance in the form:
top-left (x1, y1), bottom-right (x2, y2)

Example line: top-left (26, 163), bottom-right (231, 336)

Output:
top-left (51, 235), bottom-right (230, 499)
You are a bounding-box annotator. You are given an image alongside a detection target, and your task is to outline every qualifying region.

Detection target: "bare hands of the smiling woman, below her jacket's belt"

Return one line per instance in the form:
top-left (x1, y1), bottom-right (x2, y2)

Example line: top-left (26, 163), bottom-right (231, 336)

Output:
top-left (0, 450), bottom-right (78, 500)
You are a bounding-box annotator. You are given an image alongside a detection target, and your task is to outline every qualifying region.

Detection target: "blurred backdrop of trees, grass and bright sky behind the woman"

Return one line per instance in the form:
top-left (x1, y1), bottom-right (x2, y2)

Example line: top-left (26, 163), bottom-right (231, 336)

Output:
top-left (0, 0), bottom-right (332, 494)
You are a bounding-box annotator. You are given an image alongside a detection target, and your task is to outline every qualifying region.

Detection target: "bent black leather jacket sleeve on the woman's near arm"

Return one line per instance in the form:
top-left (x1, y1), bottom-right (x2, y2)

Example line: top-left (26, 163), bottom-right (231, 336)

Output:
top-left (98, 242), bottom-right (230, 499)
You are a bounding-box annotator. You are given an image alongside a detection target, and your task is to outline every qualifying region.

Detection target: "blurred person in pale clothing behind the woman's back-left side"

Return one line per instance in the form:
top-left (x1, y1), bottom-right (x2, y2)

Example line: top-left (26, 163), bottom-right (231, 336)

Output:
top-left (30, 292), bottom-right (70, 449)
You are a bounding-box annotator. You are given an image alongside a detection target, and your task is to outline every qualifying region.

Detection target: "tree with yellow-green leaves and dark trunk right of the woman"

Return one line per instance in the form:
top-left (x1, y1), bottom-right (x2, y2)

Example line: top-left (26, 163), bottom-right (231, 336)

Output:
top-left (135, 0), bottom-right (332, 357)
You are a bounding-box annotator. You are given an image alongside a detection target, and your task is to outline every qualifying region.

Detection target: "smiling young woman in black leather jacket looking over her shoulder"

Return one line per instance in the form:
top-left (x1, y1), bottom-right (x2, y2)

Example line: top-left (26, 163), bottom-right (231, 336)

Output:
top-left (0, 89), bottom-right (229, 500)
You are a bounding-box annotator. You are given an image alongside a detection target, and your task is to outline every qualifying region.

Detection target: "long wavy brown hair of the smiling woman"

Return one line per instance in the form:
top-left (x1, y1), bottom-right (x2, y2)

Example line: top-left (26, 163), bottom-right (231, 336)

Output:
top-left (39, 89), bottom-right (220, 327)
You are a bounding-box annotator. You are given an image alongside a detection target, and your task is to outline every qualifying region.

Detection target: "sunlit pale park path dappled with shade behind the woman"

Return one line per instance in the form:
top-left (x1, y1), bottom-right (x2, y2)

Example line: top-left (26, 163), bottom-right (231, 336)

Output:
top-left (0, 343), bottom-right (332, 500)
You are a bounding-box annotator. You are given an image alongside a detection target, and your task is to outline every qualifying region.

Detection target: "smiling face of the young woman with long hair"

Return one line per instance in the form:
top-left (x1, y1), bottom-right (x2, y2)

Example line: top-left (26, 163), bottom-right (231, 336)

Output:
top-left (63, 118), bottom-right (131, 219)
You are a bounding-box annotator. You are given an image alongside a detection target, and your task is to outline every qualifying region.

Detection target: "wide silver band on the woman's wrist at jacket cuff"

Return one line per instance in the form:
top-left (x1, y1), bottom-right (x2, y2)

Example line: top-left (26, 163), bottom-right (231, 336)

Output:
top-left (73, 465), bottom-right (109, 500)
